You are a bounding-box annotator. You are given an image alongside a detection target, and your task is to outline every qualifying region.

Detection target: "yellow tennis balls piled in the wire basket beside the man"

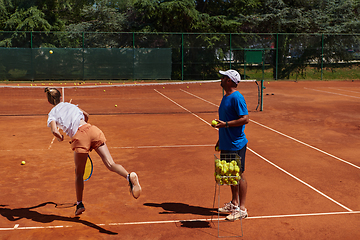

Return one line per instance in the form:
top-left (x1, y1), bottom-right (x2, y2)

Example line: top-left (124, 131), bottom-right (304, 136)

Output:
top-left (215, 159), bottom-right (241, 185)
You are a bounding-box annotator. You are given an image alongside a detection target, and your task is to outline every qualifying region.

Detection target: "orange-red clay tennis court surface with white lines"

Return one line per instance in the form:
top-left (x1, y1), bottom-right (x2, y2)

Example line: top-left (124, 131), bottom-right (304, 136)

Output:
top-left (0, 81), bottom-right (360, 239)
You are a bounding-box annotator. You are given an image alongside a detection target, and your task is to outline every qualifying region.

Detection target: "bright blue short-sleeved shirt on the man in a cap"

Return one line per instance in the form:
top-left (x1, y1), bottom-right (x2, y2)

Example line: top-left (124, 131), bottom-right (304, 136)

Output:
top-left (219, 91), bottom-right (248, 151)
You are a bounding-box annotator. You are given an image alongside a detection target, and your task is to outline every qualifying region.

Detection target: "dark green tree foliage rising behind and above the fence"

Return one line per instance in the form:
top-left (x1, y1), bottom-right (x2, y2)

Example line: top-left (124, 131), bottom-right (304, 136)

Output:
top-left (0, 0), bottom-right (360, 78)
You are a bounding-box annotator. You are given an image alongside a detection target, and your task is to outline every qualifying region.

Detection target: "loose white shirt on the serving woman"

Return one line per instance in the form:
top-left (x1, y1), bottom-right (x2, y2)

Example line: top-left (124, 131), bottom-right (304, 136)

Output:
top-left (47, 102), bottom-right (85, 138)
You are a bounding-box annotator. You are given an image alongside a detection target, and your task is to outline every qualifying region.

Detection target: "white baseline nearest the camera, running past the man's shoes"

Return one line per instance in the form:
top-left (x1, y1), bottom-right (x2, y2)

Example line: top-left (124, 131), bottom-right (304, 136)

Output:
top-left (0, 211), bottom-right (360, 231)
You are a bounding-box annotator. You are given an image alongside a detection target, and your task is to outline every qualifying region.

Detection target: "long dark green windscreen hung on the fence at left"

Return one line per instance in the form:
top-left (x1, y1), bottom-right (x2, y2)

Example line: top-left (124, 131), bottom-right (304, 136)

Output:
top-left (0, 48), bottom-right (172, 80)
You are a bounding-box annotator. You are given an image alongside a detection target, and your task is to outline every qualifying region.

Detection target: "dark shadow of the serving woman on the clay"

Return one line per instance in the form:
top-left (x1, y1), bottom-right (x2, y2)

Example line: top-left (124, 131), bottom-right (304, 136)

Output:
top-left (0, 202), bottom-right (118, 235)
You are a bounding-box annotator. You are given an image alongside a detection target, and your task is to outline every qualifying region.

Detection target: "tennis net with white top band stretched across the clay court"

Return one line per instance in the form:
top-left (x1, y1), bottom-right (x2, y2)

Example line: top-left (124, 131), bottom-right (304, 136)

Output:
top-left (0, 80), bottom-right (262, 116)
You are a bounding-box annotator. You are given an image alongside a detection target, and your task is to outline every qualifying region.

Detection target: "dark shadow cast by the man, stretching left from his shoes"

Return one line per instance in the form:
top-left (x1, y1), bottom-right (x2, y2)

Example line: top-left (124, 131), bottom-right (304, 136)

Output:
top-left (144, 202), bottom-right (225, 216)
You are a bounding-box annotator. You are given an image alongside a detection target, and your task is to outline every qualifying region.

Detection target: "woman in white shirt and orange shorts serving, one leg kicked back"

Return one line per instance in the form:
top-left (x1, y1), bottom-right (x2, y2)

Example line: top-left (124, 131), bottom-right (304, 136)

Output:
top-left (45, 88), bottom-right (141, 215)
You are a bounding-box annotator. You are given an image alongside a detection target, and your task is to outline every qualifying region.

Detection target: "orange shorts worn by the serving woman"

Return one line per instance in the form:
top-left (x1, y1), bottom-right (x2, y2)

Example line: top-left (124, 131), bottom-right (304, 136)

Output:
top-left (70, 123), bottom-right (106, 153)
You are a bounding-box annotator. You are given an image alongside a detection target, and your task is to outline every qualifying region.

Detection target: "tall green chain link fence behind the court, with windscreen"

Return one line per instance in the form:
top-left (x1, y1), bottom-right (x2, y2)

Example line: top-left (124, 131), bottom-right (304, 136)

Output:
top-left (0, 32), bottom-right (360, 81)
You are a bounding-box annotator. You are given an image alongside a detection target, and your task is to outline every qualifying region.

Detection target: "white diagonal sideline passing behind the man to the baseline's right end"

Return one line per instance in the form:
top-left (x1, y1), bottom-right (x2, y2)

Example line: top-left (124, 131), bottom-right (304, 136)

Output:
top-left (155, 90), bottom-right (353, 212)
